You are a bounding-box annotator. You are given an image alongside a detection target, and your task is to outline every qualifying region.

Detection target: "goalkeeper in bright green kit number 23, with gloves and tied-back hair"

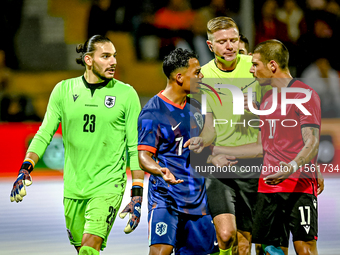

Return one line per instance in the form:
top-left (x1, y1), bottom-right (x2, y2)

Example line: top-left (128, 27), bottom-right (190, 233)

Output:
top-left (10, 35), bottom-right (144, 254)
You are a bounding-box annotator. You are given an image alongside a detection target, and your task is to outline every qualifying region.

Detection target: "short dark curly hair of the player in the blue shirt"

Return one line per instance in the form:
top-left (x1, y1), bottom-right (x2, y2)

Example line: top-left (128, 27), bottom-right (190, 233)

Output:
top-left (163, 48), bottom-right (198, 79)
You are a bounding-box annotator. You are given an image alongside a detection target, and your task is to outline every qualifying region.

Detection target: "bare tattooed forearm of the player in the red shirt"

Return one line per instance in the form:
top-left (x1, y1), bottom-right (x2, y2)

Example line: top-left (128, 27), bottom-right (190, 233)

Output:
top-left (294, 127), bottom-right (319, 167)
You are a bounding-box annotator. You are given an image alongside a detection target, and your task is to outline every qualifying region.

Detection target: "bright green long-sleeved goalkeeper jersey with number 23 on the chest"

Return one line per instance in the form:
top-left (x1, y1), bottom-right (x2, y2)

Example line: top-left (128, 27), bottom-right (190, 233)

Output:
top-left (28, 76), bottom-right (141, 199)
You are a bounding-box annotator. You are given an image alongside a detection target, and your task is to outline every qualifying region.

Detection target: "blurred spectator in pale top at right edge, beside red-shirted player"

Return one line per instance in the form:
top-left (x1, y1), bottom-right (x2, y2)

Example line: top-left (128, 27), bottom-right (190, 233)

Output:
top-left (301, 57), bottom-right (340, 118)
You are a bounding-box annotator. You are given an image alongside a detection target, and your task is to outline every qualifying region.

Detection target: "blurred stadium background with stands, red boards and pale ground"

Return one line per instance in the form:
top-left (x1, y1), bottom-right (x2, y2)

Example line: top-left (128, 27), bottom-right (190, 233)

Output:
top-left (0, 0), bottom-right (340, 255)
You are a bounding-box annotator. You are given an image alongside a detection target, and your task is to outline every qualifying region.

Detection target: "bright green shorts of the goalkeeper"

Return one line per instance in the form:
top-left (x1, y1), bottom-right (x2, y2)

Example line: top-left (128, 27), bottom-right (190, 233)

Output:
top-left (64, 194), bottom-right (123, 250)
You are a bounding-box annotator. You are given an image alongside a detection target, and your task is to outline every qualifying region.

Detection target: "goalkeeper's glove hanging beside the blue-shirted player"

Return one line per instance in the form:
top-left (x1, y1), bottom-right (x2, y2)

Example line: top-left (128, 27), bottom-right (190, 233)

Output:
top-left (119, 186), bottom-right (143, 234)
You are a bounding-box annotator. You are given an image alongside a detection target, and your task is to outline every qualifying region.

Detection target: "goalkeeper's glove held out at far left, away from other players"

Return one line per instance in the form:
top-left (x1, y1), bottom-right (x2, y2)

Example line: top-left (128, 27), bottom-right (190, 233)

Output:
top-left (10, 160), bottom-right (34, 203)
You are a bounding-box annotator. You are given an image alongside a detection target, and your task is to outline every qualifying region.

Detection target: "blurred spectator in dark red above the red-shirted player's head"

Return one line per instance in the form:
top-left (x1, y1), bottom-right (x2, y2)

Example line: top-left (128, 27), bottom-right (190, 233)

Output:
top-left (255, 0), bottom-right (289, 44)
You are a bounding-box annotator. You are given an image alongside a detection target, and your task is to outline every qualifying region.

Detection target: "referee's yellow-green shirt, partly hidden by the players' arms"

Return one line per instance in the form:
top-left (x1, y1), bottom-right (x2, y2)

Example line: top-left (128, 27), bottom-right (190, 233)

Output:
top-left (201, 54), bottom-right (271, 146)
